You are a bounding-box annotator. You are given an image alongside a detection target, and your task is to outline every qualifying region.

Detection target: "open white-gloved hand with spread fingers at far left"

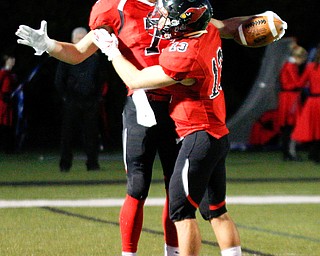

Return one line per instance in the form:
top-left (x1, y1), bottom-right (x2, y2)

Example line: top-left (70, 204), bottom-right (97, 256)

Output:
top-left (16, 20), bottom-right (55, 55)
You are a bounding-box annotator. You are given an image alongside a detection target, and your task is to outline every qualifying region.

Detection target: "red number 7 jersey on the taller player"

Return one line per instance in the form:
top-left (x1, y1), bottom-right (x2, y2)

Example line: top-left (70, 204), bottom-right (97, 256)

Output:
top-left (89, 0), bottom-right (169, 93)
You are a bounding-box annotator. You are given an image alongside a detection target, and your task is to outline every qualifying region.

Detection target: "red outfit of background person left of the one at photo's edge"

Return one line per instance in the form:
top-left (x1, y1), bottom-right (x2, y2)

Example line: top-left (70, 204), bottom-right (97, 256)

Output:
top-left (278, 58), bottom-right (302, 127)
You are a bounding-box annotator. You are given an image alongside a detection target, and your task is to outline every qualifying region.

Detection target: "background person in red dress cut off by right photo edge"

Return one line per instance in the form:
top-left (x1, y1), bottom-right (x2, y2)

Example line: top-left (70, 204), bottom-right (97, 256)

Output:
top-left (291, 44), bottom-right (320, 164)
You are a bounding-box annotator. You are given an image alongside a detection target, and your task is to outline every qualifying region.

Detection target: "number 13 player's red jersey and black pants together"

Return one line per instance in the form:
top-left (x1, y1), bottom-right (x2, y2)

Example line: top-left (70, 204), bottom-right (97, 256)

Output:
top-left (160, 24), bottom-right (229, 221)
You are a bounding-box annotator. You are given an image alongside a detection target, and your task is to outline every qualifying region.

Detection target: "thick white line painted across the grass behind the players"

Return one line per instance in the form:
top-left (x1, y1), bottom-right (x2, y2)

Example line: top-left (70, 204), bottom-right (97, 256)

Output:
top-left (0, 196), bottom-right (320, 208)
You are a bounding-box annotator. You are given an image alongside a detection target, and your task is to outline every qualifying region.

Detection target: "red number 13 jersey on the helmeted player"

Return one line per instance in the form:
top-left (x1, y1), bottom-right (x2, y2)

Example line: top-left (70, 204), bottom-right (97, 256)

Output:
top-left (160, 24), bottom-right (229, 138)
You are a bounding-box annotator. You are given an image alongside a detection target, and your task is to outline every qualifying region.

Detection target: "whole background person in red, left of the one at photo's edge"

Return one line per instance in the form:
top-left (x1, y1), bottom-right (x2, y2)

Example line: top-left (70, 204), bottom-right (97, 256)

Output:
top-left (278, 44), bottom-right (308, 161)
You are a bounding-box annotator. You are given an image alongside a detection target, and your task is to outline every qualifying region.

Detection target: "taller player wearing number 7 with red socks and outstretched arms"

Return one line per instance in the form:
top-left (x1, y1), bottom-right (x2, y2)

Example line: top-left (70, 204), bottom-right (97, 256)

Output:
top-left (16, 0), bottom-right (284, 255)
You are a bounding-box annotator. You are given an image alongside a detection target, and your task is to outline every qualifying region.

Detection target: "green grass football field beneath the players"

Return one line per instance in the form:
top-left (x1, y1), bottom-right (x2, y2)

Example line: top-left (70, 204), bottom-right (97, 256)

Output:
top-left (0, 151), bottom-right (320, 256)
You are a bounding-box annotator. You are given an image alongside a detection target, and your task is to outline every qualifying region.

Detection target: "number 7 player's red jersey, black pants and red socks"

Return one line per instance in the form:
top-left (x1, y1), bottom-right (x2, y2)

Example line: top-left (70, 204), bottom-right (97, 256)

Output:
top-left (90, 0), bottom-right (178, 252)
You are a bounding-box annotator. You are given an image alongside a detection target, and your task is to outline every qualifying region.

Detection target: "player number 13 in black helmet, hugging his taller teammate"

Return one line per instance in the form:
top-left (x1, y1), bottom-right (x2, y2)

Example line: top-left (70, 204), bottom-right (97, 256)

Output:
top-left (94, 0), bottom-right (241, 256)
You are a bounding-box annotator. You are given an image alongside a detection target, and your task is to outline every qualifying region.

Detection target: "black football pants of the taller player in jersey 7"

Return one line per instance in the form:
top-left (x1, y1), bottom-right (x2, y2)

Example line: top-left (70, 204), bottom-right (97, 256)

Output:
top-left (123, 96), bottom-right (179, 200)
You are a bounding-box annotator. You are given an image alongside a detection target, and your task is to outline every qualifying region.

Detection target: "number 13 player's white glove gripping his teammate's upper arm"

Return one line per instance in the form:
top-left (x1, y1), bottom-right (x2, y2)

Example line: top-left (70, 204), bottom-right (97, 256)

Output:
top-left (92, 28), bottom-right (121, 61)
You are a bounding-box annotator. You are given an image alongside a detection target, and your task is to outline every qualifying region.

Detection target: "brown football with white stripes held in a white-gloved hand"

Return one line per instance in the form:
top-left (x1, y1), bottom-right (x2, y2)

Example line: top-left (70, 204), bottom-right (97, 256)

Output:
top-left (234, 11), bottom-right (287, 48)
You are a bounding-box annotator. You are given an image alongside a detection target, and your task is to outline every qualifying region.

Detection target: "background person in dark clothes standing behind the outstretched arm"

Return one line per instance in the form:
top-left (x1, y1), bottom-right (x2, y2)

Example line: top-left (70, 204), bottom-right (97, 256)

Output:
top-left (55, 27), bottom-right (103, 172)
